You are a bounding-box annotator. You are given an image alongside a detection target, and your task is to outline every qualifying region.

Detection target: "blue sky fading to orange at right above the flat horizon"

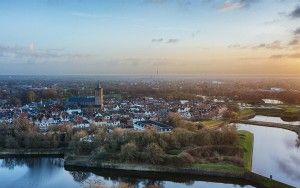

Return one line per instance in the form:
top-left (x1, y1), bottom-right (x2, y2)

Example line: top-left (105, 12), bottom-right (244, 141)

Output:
top-left (0, 0), bottom-right (300, 75)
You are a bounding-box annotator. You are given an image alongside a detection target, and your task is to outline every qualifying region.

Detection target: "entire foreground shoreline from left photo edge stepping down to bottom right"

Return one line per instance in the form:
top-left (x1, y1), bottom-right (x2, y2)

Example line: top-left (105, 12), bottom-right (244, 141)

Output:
top-left (0, 149), bottom-right (292, 188)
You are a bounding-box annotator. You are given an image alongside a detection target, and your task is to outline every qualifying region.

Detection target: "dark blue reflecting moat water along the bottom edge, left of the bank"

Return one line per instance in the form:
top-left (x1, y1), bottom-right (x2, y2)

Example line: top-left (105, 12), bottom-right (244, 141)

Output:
top-left (0, 158), bottom-right (251, 188)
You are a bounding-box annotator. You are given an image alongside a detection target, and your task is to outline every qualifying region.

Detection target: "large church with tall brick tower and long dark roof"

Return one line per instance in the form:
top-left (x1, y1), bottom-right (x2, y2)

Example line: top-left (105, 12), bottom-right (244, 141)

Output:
top-left (66, 83), bottom-right (104, 110)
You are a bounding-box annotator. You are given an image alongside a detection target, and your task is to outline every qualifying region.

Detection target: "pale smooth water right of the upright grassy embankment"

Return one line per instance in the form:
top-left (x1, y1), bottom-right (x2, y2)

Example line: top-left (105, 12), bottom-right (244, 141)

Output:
top-left (237, 124), bottom-right (300, 187)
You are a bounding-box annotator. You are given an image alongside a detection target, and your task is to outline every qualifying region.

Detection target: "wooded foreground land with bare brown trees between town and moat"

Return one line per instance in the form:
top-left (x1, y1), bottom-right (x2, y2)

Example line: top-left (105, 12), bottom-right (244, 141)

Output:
top-left (0, 114), bottom-right (285, 187)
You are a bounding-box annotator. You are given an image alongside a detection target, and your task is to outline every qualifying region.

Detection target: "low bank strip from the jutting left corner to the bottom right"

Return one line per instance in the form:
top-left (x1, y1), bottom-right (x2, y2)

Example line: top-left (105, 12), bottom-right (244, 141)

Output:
top-left (64, 159), bottom-right (293, 188)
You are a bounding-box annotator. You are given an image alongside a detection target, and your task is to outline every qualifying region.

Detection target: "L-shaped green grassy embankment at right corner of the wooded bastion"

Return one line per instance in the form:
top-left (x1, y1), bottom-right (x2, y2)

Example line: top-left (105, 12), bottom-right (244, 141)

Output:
top-left (192, 131), bottom-right (253, 173)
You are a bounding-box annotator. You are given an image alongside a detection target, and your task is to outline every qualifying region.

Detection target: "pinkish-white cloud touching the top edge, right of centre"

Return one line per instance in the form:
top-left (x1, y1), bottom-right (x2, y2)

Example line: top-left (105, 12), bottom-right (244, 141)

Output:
top-left (219, 0), bottom-right (256, 11)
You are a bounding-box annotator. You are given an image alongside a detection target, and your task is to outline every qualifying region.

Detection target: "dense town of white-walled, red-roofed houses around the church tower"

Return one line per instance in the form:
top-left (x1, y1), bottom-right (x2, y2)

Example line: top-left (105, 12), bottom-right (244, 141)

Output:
top-left (0, 78), bottom-right (226, 131)
